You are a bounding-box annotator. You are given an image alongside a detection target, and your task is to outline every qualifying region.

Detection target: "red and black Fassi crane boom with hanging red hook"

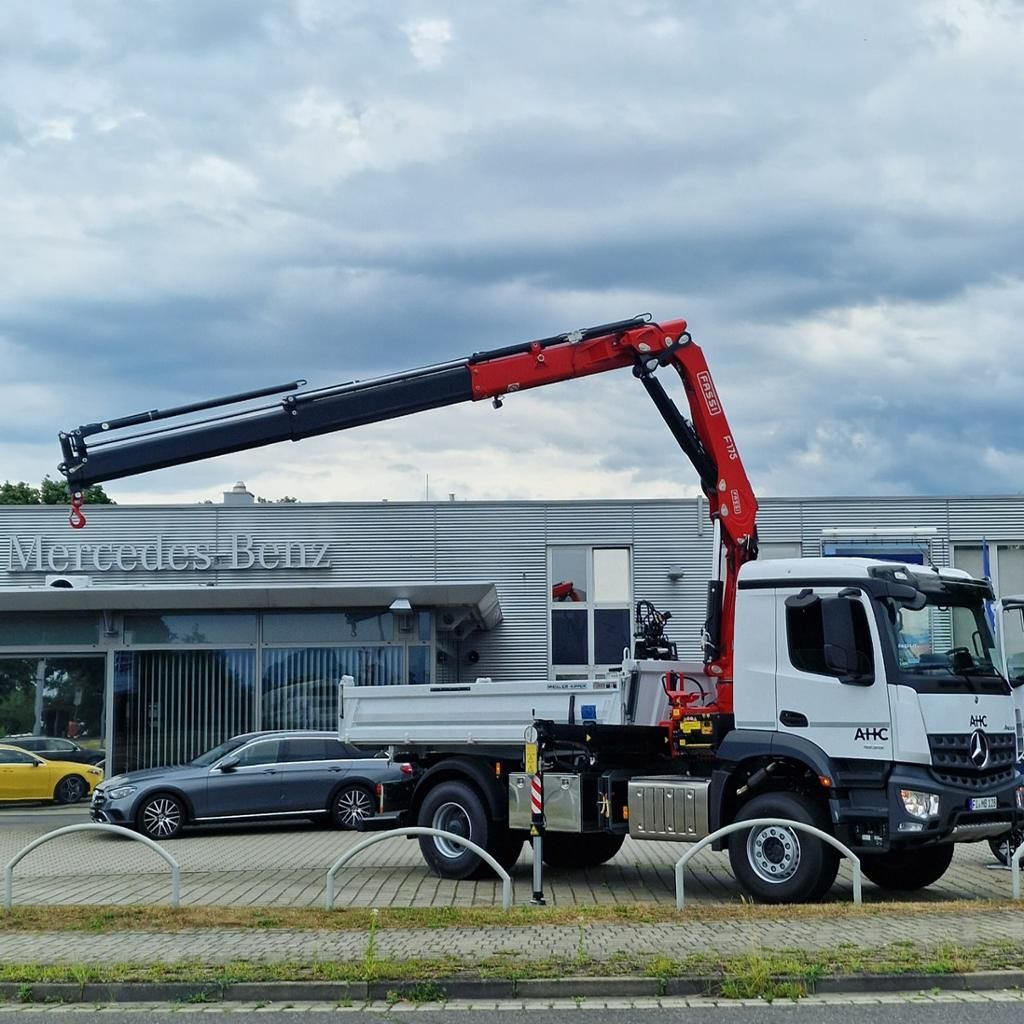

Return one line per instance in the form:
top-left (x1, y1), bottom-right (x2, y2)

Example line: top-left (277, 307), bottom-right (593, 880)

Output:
top-left (58, 316), bottom-right (757, 683)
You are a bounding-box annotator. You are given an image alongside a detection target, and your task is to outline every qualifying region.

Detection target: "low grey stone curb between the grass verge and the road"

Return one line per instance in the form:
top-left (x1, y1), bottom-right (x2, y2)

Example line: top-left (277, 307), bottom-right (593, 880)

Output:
top-left (0, 971), bottom-right (1024, 1004)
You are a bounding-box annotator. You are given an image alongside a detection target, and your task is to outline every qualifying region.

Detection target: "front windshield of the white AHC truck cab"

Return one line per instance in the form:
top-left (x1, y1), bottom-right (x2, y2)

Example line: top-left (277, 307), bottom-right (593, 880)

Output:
top-left (885, 594), bottom-right (1006, 690)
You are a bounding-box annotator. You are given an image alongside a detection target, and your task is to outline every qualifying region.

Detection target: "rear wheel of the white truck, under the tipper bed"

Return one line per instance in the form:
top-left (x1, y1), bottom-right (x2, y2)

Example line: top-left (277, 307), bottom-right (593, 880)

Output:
top-left (416, 781), bottom-right (493, 879)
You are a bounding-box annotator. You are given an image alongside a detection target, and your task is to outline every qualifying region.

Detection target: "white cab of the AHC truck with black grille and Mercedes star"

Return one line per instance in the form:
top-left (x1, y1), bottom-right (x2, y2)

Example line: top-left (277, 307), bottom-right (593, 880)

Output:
top-left (719, 558), bottom-right (1021, 864)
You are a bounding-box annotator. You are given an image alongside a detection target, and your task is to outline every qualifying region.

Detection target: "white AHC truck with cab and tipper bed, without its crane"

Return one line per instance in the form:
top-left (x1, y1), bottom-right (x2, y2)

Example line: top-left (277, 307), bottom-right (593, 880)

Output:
top-left (341, 558), bottom-right (1024, 902)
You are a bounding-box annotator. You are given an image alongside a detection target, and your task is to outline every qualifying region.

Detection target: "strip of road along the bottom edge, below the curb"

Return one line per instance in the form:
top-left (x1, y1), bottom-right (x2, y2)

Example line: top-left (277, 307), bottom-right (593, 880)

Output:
top-left (0, 993), bottom-right (1024, 1024)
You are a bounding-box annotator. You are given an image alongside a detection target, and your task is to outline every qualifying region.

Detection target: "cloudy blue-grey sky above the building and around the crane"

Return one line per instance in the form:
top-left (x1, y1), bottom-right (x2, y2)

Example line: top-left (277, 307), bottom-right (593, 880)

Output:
top-left (0, 0), bottom-right (1024, 503)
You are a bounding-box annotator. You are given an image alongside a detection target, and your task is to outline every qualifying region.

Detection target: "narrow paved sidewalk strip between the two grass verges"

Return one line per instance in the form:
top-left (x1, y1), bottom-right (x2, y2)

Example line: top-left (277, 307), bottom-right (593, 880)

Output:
top-left (0, 910), bottom-right (1024, 965)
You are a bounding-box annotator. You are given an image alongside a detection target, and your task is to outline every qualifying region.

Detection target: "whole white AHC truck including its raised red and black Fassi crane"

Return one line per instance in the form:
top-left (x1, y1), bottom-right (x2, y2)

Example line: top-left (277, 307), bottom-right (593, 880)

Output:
top-left (59, 317), bottom-right (1024, 901)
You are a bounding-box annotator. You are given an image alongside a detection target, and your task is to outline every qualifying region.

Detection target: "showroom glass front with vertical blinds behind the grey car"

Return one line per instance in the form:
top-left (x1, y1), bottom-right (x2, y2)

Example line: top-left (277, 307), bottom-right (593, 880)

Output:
top-left (103, 608), bottom-right (433, 773)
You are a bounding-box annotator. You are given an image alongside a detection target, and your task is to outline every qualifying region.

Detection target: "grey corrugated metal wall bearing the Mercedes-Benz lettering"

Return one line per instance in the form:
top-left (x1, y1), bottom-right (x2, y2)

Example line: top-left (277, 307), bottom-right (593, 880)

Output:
top-left (0, 496), bottom-right (1024, 680)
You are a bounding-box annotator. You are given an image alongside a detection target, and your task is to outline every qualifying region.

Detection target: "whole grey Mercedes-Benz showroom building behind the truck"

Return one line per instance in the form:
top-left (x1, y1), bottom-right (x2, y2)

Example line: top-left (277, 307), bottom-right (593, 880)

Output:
top-left (0, 484), bottom-right (1024, 773)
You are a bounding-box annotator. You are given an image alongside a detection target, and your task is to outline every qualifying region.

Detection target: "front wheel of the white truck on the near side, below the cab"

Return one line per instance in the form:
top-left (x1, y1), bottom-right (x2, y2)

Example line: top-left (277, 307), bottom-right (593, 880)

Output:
top-left (729, 793), bottom-right (839, 903)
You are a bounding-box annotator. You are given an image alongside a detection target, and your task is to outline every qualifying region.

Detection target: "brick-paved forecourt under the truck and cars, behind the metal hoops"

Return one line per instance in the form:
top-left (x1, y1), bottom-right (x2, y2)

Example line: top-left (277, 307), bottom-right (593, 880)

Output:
top-left (0, 807), bottom-right (1011, 907)
